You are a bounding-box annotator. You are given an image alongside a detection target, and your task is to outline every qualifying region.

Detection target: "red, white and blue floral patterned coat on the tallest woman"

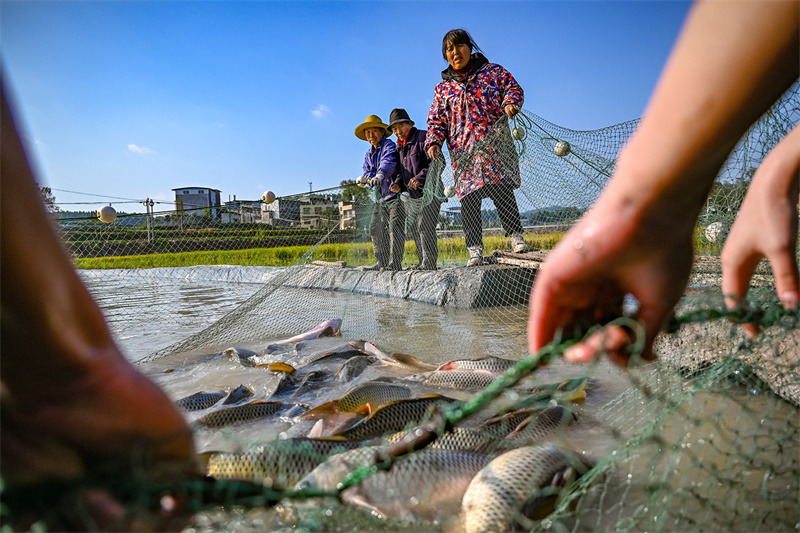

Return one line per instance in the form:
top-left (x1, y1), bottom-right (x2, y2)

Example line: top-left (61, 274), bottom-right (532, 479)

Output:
top-left (425, 53), bottom-right (524, 199)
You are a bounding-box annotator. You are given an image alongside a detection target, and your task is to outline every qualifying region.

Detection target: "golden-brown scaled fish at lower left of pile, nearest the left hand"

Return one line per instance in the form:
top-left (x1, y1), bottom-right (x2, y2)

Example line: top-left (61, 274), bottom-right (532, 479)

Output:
top-left (203, 437), bottom-right (361, 490)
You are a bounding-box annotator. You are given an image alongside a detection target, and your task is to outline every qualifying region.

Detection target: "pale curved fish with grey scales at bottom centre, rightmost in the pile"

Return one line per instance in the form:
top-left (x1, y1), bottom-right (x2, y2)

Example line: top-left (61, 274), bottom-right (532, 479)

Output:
top-left (461, 445), bottom-right (593, 533)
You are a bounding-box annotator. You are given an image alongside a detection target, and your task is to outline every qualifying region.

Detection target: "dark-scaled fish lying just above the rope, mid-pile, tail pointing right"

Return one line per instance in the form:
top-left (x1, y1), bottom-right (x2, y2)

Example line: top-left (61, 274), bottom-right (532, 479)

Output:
top-left (336, 394), bottom-right (462, 440)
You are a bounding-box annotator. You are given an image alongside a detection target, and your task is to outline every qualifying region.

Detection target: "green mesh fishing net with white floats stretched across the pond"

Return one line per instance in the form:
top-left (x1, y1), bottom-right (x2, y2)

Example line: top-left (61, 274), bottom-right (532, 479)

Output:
top-left (3, 84), bottom-right (800, 531)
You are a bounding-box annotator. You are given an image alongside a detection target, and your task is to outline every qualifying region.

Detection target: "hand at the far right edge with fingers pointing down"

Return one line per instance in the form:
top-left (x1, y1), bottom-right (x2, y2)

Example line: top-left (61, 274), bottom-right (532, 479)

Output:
top-left (722, 127), bottom-right (800, 337)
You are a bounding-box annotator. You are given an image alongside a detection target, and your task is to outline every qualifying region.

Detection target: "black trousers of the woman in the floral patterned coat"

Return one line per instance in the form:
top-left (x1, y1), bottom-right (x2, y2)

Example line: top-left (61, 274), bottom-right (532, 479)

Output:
top-left (461, 183), bottom-right (522, 248)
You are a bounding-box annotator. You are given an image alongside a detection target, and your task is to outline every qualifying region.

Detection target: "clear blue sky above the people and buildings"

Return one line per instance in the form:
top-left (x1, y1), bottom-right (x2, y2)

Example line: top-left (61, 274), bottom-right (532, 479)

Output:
top-left (0, 0), bottom-right (691, 212)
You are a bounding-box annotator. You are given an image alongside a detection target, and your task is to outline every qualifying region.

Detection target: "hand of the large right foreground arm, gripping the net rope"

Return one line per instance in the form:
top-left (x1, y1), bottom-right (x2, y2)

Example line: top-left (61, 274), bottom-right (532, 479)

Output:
top-left (528, 197), bottom-right (693, 366)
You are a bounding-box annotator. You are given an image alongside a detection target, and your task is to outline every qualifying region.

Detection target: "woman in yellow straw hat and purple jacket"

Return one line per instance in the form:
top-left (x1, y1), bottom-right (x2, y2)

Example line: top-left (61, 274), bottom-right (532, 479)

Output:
top-left (355, 115), bottom-right (406, 270)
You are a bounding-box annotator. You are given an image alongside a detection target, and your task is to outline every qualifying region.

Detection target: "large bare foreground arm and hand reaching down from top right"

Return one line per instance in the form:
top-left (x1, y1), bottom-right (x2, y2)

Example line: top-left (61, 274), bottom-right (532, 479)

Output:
top-left (528, 1), bottom-right (799, 364)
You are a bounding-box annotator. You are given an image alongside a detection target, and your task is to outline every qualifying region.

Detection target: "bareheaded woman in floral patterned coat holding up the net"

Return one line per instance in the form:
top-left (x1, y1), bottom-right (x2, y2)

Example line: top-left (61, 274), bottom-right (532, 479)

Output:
top-left (425, 29), bottom-right (529, 266)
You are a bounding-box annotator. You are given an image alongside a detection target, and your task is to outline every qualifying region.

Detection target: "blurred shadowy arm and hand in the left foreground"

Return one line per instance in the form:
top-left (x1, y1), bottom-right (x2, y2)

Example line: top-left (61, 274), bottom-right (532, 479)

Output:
top-left (0, 84), bottom-right (194, 530)
